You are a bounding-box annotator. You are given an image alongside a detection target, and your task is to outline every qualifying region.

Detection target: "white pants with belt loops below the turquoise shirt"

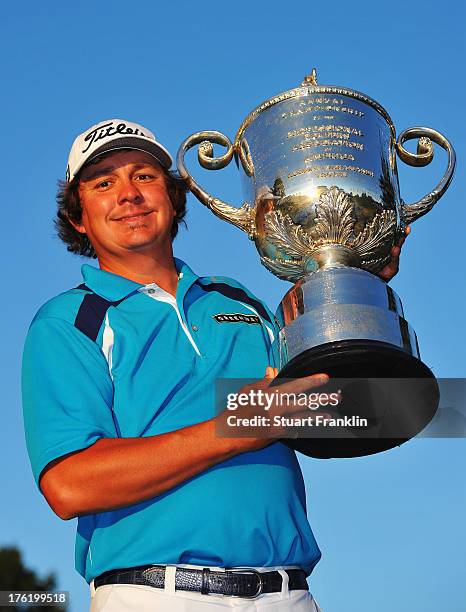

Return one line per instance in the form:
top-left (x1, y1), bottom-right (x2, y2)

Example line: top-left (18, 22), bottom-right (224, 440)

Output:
top-left (90, 565), bottom-right (322, 612)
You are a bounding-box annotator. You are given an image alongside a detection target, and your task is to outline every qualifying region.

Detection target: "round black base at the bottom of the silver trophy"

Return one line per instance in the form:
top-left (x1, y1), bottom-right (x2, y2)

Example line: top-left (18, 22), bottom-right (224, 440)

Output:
top-left (275, 340), bottom-right (440, 459)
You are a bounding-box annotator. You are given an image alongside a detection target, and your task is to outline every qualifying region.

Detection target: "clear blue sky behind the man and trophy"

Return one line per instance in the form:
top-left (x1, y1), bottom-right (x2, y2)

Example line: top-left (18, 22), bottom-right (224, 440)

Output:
top-left (0, 0), bottom-right (466, 612)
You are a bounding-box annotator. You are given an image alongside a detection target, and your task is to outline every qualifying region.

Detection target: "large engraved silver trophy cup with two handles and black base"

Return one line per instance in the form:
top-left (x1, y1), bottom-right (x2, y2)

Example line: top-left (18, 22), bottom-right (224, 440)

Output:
top-left (177, 70), bottom-right (455, 457)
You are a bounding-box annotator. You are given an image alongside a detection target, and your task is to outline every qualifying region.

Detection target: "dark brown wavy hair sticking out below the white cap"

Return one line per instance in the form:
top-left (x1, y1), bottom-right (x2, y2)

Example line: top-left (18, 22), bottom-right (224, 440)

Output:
top-left (54, 151), bottom-right (188, 259)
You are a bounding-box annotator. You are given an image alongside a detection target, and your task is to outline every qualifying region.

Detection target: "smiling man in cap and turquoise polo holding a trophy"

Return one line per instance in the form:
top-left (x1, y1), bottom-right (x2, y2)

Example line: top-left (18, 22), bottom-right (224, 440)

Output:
top-left (23, 120), bottom-right (401, 612)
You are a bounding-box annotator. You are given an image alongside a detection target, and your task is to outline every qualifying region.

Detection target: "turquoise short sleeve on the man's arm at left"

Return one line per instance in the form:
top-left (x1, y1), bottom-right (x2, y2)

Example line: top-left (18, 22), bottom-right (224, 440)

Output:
top-left (22, 318), bottom-right (118, 485)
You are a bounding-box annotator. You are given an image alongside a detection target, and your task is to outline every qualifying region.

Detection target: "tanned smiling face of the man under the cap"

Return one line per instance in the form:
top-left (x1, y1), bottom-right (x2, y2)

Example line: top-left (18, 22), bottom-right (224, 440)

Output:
top-left (73, 150), bottom-right (175, 260)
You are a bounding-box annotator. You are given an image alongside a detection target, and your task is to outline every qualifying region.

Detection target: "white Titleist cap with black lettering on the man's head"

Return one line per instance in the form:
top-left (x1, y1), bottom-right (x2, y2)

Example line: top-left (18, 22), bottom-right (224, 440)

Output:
top-left (66, 119), bottom-right (173, 183)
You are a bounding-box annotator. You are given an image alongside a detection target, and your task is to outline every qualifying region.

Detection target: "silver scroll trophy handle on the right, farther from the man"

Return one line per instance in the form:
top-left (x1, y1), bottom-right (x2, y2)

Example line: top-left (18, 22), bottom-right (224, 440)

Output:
top-left (396, 127), bottom-right (456, 225)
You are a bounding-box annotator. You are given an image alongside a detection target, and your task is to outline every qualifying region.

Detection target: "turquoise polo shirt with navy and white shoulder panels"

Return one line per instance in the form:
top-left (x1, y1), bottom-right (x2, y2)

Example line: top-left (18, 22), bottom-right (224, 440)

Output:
top-left (23, 259), bottom-right (320, 582)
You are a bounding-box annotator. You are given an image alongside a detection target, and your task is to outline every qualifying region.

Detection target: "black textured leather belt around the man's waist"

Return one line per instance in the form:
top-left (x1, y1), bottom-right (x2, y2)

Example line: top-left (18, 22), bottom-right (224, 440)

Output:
top-left (94, 565), bottom-right (309, 598)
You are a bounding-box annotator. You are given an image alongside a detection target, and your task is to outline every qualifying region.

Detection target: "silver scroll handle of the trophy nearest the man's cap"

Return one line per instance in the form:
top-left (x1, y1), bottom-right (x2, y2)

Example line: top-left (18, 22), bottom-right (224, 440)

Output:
top-left (176, 132), bottom-right (255, 239)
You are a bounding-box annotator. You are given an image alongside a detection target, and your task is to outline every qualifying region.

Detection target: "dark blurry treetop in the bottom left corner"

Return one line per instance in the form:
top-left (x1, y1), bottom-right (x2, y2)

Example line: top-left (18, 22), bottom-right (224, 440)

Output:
top-left (0, 546), bottom-right (66, 612)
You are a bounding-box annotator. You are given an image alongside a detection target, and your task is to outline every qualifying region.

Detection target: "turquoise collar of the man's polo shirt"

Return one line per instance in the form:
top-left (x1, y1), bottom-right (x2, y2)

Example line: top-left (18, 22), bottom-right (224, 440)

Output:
top-left (81, 257), bottom-right (199, 302)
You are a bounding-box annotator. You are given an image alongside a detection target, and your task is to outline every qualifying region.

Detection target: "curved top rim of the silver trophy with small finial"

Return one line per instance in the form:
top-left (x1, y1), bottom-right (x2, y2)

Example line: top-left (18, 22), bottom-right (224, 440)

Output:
top-left (235, 68), bottom-right (396, 148)
